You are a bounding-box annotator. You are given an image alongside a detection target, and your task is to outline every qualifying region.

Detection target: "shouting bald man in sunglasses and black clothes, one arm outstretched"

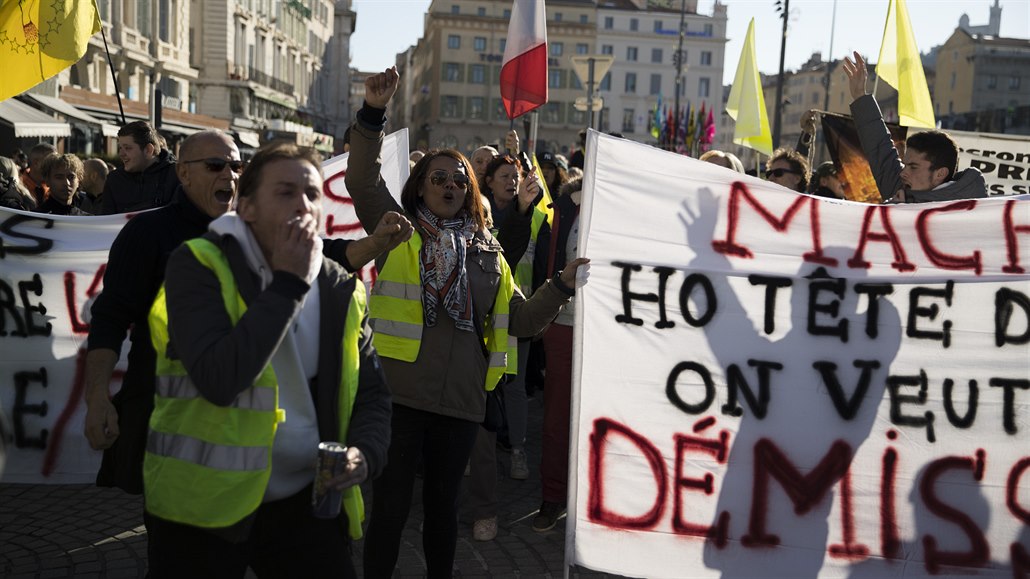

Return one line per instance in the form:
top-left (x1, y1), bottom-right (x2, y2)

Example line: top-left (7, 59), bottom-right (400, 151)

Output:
top-left (84, 131), bottom-right (411, 495)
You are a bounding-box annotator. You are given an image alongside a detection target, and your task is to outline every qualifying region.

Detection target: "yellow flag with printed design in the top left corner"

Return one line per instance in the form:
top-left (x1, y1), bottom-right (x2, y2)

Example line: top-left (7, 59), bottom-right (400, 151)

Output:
top-left (0, 0), bottom-right (100, 101)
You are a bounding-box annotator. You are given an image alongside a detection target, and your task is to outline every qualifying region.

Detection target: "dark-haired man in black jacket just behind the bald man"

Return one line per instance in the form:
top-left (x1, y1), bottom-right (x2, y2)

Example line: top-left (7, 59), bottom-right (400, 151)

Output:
top-left (101, 121), bottom-right (179, 215)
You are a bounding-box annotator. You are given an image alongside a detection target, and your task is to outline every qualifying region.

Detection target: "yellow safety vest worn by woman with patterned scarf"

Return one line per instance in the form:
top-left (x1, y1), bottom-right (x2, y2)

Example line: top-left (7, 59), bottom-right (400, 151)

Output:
top-left (369, 231), bottom-right (518, 390)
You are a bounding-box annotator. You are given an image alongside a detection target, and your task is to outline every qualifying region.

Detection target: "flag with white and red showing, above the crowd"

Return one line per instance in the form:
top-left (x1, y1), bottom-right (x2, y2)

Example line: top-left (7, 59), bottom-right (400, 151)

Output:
top-left (501, 0), bottom-right (547, 118)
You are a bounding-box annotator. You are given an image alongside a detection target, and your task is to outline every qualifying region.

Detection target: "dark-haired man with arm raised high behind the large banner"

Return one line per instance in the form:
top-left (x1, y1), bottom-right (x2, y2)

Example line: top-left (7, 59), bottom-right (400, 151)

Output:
top-left (844, 52), bottom-right (987, 203)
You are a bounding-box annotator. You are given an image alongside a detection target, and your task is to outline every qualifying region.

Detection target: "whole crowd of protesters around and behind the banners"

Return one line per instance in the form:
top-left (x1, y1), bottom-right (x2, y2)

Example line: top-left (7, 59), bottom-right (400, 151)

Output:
top-left (0, 47), bottom-right (986, 577)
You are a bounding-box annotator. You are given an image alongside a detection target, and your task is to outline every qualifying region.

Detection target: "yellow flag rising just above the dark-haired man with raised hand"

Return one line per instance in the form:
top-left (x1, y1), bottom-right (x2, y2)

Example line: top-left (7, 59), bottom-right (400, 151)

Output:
top-left (877, 0), bottom-right (937, 129)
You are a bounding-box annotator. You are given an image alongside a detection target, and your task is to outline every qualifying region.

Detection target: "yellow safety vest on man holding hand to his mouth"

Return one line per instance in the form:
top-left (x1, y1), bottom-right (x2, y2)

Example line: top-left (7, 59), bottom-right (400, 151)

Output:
top-left (143, 238), bottom-right (366, 539)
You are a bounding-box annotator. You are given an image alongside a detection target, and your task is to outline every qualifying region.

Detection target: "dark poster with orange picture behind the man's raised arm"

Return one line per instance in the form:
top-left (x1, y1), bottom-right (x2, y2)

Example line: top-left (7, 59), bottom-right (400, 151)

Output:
top-left (821, 112), bottom-right (908, 203)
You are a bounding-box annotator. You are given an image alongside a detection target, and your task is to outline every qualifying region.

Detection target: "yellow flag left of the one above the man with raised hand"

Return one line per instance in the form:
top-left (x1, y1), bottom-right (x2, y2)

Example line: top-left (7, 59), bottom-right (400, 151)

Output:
top-left (726, 19), bottom-right (773, 155)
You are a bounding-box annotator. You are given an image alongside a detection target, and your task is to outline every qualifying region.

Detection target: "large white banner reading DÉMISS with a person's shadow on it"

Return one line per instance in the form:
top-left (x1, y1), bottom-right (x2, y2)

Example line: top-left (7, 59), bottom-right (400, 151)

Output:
top-left (567, 132), bottom-right (1030, 577)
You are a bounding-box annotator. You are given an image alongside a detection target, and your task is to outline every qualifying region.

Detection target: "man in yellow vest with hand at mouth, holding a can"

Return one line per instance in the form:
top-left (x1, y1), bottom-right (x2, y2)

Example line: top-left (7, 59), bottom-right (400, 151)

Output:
top-left (143, 144), bottom-right (401, 577)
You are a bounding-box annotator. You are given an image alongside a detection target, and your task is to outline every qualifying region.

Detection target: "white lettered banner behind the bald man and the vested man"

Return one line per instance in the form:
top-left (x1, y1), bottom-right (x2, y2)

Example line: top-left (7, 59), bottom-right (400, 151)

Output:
top-left (0, 130), bottom-right (409, 483)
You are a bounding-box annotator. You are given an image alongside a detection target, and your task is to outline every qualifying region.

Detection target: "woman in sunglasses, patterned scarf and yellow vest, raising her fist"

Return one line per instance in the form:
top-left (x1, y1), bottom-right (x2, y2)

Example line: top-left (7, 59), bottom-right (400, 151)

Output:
top-left (346, 69), bottom-right (586, 578)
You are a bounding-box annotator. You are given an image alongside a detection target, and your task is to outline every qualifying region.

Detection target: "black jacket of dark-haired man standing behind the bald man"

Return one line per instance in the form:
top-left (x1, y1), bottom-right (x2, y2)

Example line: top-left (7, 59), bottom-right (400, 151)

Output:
top-left (100, 150), bottom-right (179, 215)
